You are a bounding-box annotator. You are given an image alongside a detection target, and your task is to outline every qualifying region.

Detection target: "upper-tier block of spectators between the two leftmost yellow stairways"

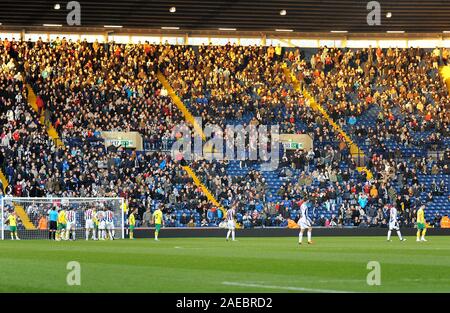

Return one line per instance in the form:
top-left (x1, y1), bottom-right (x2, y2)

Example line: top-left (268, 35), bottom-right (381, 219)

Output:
top-left (20, 38), bottom-right (181, 149)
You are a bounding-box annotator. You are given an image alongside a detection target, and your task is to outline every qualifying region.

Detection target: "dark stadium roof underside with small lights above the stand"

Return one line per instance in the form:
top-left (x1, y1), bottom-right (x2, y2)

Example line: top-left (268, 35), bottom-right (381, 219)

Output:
top-left (0, 0), bottom-right (450, 33)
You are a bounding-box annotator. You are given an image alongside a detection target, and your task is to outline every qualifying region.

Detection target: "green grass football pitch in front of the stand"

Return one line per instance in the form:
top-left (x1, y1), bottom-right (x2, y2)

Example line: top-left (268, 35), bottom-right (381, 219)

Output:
top-left (0, 236), bottom-right (450, 293)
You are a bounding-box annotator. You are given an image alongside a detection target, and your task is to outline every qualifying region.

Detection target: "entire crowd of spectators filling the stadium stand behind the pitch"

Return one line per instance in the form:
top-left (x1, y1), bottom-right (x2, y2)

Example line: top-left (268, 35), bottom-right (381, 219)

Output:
top-left (0, 38), bottom-right (450, 227)
